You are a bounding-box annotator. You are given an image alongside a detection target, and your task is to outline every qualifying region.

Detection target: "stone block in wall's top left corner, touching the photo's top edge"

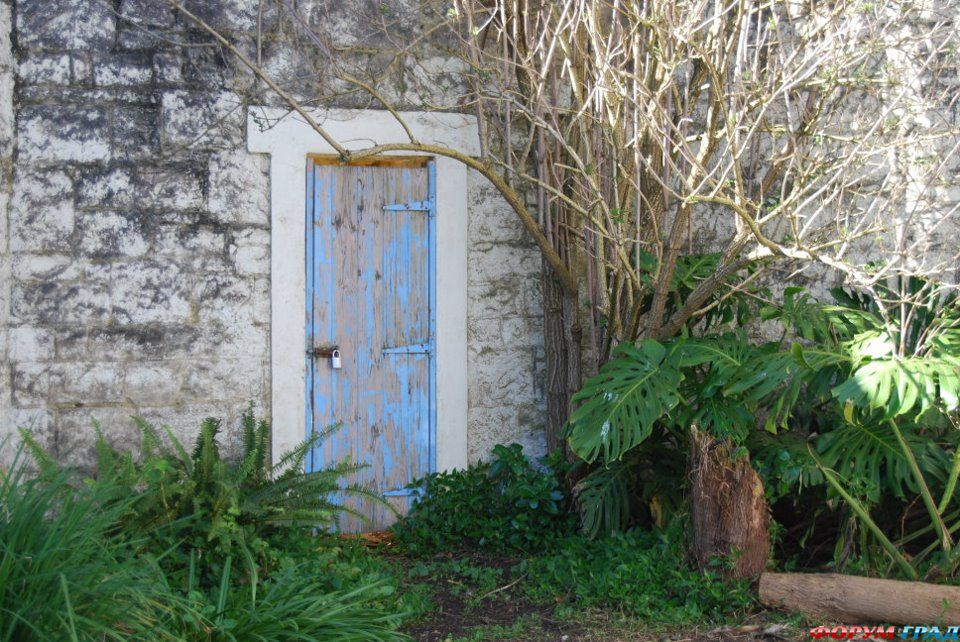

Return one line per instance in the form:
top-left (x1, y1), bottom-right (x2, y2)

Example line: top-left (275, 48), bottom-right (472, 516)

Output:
top-left (16, 0), bottom-right (116, 51)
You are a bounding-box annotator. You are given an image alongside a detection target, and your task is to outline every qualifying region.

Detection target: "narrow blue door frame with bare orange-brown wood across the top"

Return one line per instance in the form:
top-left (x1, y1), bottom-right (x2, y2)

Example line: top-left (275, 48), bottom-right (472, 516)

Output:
top-left (304, 154), bottom-right (438, 476)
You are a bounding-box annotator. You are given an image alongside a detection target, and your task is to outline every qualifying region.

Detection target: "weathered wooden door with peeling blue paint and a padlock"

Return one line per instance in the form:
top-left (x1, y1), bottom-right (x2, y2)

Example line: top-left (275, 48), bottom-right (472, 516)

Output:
top-left (306, 159), bottom-right (435, 532)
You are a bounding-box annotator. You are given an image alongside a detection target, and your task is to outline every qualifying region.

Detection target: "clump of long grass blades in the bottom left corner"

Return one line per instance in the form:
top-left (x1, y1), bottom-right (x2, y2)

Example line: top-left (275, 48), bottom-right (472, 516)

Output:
top-left (0, 448), bottom-right (177, 641)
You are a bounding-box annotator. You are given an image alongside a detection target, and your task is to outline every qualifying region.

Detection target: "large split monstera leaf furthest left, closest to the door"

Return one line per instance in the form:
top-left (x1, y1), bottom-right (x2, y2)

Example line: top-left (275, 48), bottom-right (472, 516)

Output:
top-left (567, 340), bottom-right (683, 462)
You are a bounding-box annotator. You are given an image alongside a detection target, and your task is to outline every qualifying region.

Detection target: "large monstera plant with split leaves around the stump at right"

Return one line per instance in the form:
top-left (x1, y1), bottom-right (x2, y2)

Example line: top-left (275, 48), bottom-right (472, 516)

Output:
top-left (567, 278), bottom-right (960, 577)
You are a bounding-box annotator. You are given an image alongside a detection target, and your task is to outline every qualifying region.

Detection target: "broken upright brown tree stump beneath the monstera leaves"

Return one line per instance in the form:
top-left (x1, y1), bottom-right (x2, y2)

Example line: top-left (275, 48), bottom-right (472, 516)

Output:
top-left (690, 427), bottom-right (770, 578)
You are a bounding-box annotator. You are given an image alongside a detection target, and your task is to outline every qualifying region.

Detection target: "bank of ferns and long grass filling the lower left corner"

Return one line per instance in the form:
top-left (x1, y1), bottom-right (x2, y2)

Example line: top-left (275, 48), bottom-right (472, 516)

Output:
top-left (0, 413), bottom-right (411, 641)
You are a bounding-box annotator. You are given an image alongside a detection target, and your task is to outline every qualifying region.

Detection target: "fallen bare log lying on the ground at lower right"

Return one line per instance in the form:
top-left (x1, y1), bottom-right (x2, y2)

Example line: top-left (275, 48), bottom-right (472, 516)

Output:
top-left (760, 573), bottom-right (960, 624)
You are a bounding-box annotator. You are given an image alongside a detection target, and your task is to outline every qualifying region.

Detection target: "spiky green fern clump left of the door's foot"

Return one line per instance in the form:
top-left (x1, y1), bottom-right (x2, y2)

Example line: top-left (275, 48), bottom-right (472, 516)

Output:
top-left (24, 410), bottom-right (376, 585)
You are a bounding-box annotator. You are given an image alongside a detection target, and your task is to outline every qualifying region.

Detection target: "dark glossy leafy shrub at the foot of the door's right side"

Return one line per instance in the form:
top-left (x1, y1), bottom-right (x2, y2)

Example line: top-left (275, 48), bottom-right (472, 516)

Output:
top-left (394, 444), bottom-right (572, 554)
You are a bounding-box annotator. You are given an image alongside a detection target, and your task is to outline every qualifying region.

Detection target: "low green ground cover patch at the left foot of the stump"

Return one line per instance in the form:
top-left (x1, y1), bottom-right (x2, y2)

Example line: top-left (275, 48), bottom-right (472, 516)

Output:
top-left (519, 523), bottom-right (753, 625)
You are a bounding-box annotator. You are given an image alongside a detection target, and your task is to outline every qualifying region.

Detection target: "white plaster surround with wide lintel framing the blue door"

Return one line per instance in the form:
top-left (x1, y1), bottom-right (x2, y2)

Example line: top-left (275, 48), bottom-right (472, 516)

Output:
top-left (247, 107), bottom-right (479, 470)
